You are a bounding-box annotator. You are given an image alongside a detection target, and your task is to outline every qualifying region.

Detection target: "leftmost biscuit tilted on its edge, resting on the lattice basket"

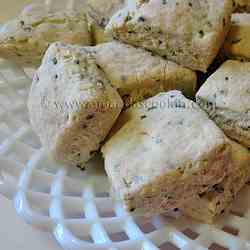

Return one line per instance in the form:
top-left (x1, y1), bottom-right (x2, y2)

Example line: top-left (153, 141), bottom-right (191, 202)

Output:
top-left (28, 42), bottom-right (123, 166)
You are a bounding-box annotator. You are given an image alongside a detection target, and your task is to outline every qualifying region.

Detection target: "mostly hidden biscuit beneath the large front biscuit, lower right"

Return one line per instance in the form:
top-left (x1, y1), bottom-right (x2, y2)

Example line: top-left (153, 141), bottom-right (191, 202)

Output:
top-left (182, 142), bottom-right (250, 223)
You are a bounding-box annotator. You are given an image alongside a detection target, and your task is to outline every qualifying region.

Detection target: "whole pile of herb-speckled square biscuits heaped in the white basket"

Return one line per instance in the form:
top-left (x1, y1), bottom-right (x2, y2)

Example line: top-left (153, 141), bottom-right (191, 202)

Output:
top-left (0, 0), bottom-right (250, 223)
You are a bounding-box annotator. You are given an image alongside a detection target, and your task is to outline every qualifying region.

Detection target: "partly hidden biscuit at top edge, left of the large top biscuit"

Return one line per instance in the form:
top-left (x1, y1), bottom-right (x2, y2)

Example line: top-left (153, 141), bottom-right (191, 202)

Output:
top-left (86, 0), bottom-right (125, 44)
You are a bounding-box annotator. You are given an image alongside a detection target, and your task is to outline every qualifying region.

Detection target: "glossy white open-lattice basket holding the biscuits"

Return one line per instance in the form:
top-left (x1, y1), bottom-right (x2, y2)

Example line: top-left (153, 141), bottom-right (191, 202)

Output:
top-left (0, 0), bottom-right (250, 250)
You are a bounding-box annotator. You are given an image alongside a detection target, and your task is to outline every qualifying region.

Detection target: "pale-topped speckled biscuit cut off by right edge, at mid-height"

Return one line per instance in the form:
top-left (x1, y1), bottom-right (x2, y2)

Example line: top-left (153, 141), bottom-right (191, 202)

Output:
top-left (196, 60), bottom-right (250, 148)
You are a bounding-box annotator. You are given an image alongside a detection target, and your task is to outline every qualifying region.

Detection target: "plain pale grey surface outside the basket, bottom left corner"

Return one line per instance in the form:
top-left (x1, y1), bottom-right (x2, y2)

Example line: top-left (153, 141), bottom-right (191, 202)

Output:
top-left (0, 195), bottom-right (61, 250)
